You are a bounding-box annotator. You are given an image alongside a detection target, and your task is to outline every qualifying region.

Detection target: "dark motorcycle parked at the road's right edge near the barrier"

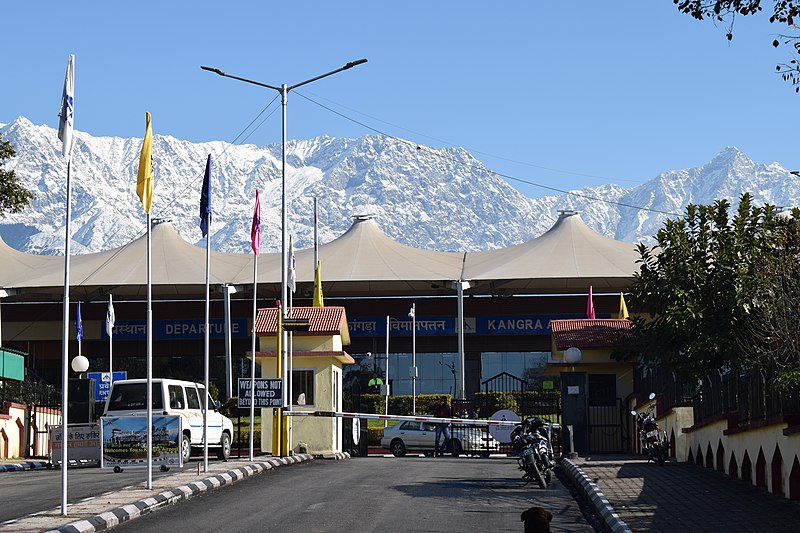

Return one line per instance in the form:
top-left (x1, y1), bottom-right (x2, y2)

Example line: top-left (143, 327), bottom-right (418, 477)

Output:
top-left (511, 417), bottom-right (558, 489)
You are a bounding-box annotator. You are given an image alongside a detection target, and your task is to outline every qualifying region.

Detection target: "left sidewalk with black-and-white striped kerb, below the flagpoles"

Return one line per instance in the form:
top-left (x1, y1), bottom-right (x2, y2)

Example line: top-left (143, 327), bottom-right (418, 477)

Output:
top-left (0, 453), bottom-right (349, 533)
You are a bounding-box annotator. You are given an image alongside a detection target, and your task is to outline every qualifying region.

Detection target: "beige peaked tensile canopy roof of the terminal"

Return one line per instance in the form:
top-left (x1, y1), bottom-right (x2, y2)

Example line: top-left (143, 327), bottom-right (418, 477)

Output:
top-left (0, 212), bottom-right (638, 298)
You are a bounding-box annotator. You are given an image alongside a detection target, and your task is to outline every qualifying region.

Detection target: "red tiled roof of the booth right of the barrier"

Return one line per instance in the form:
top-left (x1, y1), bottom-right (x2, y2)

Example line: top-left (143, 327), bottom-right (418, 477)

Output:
top-left (550, 318), bottom-right (634, 350)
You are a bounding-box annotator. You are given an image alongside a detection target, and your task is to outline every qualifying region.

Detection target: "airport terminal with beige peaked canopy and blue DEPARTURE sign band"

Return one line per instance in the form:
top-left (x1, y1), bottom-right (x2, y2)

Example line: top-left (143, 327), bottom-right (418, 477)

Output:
top-left (0, 211), bottom-right (638, 397)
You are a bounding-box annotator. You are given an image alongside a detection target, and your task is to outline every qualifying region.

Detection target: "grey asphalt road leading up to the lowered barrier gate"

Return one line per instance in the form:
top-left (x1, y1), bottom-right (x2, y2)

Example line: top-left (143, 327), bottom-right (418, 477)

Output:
top-left (115, 457), bottom-right (594, 533)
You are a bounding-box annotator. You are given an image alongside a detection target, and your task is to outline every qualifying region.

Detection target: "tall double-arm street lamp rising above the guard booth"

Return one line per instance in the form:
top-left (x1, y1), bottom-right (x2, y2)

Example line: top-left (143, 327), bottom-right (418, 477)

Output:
top-left (205, 59), bottom-right (367, 454)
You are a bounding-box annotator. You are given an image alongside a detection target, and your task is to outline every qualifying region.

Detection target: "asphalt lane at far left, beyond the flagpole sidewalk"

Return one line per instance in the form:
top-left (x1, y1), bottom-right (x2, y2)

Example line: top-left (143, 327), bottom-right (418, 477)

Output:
top-left (0, 457), bottom-right (211, 523)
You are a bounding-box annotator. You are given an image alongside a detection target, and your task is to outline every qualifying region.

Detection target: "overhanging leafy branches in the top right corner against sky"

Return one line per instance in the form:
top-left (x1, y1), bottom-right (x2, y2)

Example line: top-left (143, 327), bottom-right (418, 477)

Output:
top-left (672, 0), bottom-right (800, 93)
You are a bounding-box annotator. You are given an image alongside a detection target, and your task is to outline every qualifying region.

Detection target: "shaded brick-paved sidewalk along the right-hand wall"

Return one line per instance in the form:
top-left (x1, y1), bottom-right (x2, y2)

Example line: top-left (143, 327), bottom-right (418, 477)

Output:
top-left (564, 456), bottom-right (800, 533)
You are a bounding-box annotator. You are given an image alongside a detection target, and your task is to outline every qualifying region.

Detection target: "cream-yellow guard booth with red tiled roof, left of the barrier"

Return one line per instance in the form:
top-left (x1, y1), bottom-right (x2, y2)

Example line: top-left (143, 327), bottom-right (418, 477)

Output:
top-left (250, 307), bottom-right (355, 454)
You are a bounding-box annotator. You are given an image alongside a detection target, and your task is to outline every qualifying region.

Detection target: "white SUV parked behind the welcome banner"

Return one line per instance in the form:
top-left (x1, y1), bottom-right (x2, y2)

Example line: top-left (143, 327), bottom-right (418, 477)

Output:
top-left (103, 378), bottom-right (233, 463)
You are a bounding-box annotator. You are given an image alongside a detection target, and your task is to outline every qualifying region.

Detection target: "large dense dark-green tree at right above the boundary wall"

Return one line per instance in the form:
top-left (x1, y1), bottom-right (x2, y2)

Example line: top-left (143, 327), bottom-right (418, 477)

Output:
top-left (632, 194), bottom-right (800, 377)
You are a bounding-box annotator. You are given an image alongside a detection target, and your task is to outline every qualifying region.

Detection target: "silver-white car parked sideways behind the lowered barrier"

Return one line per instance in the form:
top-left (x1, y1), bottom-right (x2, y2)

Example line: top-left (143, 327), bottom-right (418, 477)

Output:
top-left (381, 420), bottom-right (500, 457)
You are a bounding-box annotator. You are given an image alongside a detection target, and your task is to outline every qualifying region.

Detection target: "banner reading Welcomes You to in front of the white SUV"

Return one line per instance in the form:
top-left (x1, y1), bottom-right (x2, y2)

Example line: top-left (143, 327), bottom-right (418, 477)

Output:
top-left (100, 416), bottom-right (183, 468)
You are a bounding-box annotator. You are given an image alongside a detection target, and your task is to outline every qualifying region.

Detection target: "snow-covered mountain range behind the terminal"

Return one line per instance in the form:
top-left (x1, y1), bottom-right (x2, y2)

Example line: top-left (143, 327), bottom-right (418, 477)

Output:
top-left (0, 117), bottom-right (800, 254)
